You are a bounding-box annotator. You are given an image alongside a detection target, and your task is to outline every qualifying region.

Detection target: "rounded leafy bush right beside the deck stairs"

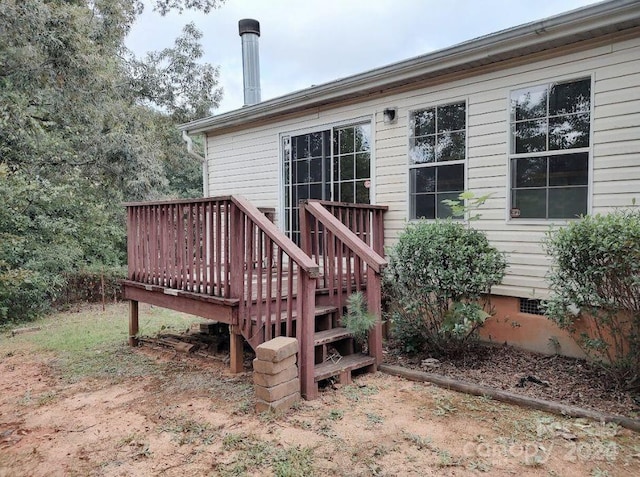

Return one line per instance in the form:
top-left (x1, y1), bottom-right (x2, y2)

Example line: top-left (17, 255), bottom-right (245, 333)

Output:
top-left (384, 220), bottom-right (506, 355)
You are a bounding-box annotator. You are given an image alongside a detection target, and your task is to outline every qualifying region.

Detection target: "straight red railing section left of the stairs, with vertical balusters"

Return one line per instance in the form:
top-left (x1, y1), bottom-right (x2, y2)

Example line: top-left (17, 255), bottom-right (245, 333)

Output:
top-left (126, 197), bottom-right (232, 298)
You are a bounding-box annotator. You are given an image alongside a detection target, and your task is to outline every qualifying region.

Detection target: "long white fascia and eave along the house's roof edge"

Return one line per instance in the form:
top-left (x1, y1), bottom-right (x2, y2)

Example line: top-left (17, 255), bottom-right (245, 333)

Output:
top-left (179, 0), bottom-right (640, 134)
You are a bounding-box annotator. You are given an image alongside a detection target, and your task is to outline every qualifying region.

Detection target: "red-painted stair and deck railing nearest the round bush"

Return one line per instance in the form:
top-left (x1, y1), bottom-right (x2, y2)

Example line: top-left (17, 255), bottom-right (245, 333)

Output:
top-left (300, 200), bottom-right (387, 364)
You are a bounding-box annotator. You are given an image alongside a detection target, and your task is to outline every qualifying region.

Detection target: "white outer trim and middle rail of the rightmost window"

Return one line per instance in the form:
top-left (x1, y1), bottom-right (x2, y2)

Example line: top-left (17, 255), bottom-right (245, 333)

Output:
top-left (505, 71), bottom-right (595, 226)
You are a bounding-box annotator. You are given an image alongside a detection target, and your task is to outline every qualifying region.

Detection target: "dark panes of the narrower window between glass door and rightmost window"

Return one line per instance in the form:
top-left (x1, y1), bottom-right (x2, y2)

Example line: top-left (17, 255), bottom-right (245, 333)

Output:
top-left (409, 102), bottom-right (467, 219)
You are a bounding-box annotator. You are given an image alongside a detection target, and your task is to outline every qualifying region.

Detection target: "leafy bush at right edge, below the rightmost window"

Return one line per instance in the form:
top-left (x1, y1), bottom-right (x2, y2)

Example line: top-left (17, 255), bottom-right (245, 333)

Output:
top-left (545, 210), bottom-right (640, 388)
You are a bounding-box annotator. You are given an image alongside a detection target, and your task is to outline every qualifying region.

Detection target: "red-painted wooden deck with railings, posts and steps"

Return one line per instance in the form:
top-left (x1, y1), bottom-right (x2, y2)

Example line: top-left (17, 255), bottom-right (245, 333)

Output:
top-left (123, 196), bottom-right (386, 399)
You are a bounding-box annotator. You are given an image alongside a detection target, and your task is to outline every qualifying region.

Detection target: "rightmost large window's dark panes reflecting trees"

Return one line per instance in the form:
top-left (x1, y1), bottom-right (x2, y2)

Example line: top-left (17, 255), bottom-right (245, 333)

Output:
top-left (510, 78), bottom-right (591, 219)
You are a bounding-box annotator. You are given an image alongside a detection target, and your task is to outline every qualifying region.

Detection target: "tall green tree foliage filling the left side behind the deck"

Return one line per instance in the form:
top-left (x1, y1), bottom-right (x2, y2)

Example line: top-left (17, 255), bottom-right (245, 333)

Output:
top-left (0, 0), bottom-right (222, 322)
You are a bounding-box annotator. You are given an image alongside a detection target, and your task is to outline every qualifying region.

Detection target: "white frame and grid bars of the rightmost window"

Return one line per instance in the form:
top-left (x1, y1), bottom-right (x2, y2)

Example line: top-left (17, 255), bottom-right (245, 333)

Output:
top-left (505, 73), bottom-right (595, 221)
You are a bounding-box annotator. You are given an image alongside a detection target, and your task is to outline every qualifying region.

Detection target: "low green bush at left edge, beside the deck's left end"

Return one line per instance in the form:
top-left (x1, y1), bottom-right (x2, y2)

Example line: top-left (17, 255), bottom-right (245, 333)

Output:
top-left (0, 164), bottom-right (126, 324)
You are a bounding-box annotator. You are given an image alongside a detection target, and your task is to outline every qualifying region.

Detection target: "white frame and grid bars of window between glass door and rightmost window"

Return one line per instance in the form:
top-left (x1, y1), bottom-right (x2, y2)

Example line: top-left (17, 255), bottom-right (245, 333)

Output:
top-left (406, 97), bottom-right (469, 222)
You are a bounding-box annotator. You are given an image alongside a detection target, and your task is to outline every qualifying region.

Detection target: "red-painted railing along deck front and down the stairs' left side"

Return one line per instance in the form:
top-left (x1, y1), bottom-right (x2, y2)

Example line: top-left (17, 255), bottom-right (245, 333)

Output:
top-left (126, 196), bottom-right (319, 393)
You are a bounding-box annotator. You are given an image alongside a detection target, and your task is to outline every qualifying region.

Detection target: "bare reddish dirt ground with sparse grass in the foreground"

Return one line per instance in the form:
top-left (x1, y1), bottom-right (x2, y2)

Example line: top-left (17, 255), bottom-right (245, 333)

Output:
top-left (0, 346), bottom-right (640, 477)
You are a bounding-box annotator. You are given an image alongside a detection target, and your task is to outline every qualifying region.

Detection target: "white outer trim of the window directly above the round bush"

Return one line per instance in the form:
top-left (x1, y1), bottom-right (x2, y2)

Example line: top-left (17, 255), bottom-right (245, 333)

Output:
top-left (405, 100), bottom-right (469, 223)
